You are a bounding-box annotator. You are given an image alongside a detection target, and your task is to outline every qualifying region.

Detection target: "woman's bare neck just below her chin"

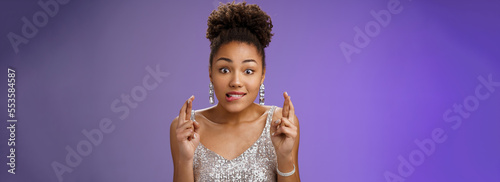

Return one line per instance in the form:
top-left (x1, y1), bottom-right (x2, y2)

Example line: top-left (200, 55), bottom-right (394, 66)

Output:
top-left (212, 103), bottom-right (265, 125)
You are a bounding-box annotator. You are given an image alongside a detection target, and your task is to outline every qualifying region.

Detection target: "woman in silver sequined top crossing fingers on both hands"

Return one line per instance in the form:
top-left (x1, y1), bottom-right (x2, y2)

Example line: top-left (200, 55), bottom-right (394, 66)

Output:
top-left (170, 2), bottom-right (300, 182)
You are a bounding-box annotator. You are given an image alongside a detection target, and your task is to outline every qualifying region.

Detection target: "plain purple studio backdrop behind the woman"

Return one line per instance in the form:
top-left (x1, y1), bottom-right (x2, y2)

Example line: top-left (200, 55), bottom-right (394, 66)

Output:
top-left (0, 0), bottom-right (500, 182)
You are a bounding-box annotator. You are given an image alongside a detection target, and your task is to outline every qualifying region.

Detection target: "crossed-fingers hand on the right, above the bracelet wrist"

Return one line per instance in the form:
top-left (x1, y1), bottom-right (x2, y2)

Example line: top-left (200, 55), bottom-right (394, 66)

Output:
top-left (271, 92), bottom-right (297, 157)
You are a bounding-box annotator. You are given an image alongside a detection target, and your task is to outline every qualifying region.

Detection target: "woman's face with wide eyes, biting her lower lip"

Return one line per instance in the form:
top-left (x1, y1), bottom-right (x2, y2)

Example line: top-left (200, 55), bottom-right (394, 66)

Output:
top-left (209, 41), bottom-right (265, 112)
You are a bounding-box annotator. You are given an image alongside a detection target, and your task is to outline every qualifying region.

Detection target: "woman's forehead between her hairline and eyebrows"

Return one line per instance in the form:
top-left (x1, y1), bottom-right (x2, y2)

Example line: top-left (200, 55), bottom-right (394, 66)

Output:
top-left (214, 41), bottom-right (262, 64)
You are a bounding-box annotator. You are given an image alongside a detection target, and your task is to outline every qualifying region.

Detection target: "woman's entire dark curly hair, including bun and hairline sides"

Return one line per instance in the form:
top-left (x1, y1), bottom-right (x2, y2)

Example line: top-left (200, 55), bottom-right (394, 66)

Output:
top-left (207, 1), bottom-right (274, 72)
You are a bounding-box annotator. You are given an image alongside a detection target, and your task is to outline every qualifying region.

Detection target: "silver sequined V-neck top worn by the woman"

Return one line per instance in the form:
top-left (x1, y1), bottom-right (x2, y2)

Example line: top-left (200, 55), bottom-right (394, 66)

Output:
top-left (191, 106), bottom-right (277, 181)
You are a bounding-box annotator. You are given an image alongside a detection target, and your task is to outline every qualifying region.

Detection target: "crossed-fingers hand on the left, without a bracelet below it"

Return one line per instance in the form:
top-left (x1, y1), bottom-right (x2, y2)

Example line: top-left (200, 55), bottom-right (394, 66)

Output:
top-left (175, 96), bottom-right (200, 160)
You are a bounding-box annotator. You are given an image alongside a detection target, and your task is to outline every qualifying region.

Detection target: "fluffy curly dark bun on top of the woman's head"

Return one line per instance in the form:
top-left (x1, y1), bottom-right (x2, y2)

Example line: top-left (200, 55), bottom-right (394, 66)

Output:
top-left (207, 1), bottom-right (273, 48)
